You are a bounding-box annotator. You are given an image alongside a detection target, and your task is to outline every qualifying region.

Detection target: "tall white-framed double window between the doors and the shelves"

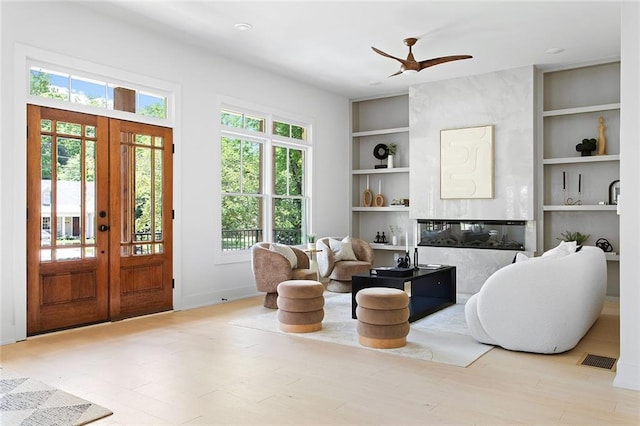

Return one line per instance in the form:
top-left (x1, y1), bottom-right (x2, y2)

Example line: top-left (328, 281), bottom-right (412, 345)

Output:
top-left (220, 108), bottom-right (311, 252)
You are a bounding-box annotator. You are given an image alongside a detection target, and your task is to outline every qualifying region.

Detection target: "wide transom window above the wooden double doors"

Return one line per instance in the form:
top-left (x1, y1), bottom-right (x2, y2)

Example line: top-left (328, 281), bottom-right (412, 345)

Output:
top-left (29, 66), bottom-right (167, 118)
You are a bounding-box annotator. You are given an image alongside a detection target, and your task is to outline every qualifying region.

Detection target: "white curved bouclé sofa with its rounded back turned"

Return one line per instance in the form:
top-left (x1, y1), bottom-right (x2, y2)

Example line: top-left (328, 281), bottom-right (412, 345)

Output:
top-left (465, 246), bottom-right (607, 354)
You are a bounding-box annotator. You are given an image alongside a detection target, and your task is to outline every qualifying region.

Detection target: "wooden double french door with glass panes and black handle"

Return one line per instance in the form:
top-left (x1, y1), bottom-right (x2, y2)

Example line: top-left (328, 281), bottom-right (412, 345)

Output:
top-left (27, 105), bottom-right (173, 335)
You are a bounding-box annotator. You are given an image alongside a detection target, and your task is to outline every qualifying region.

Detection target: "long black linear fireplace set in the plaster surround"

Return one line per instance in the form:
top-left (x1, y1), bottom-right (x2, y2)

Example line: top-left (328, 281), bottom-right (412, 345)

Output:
top-left (418, 219), bottom-right (526, 251)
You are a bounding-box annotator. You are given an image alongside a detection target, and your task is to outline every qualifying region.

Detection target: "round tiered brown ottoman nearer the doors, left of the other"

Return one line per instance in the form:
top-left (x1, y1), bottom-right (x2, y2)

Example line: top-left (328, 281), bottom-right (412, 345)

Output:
top-left (277, 280), bottom-right (324, 333)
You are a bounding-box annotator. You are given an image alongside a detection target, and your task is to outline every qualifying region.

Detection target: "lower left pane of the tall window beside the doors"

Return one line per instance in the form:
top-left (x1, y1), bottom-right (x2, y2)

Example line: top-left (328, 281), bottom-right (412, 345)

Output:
top-left (222, 195), bottom-right (263, 251)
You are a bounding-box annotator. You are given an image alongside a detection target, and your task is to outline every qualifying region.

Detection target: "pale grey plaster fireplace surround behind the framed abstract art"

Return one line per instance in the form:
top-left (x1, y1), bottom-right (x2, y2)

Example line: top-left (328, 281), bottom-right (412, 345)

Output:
top-left (409, 67), bottom-right (536, 293)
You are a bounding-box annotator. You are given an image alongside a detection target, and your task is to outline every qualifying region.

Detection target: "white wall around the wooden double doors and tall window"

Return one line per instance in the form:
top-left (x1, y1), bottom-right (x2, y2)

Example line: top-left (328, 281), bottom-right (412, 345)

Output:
top-left (0, 2), bottom-right (349, 343)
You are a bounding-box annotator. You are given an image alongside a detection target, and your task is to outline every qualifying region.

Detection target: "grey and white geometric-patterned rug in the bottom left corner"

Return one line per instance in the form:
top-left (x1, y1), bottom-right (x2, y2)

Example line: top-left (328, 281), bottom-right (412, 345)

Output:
top-left (0, 369), bottom-right (113, 426)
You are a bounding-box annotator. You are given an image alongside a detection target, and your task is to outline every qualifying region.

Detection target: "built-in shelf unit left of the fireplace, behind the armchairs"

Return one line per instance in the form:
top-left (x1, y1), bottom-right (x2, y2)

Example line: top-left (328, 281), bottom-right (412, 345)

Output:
top-left (350, 93), bottom-right (415, 265)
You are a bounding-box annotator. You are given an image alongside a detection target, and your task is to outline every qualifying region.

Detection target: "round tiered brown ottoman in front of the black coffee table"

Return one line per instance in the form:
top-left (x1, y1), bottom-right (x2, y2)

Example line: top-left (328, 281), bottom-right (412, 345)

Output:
top-left (356, 287), bottom-right (409, 349)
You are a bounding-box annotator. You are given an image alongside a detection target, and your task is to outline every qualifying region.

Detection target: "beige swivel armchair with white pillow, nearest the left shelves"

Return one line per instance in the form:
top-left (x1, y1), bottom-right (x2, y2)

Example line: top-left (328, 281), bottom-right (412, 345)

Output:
top-left (316, 237), bottom-right (373, 293)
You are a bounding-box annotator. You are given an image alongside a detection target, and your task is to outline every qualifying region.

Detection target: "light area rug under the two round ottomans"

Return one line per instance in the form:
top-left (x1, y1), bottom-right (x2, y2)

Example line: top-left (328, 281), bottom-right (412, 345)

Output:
top-left (231, 292), bottom-right (493, 367)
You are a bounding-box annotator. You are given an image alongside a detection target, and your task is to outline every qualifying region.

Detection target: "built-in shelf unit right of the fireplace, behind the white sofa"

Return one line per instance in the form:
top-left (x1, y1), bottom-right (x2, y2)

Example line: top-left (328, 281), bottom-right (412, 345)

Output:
top-left (538, 62), bottom-right (620, 295)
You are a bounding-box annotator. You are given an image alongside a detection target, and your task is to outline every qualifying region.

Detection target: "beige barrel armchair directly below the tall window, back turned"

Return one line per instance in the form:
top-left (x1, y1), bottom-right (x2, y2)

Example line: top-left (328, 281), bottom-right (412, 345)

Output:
top-left (251, 242), bottom-right (318, 309)
